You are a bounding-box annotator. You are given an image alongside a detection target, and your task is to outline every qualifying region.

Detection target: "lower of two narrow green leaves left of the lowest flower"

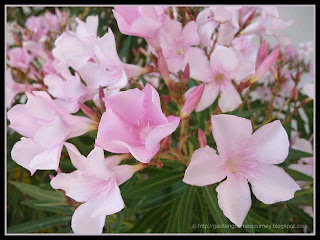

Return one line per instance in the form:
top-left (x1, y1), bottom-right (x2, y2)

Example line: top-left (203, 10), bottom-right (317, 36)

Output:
top-left (21, 200), bottom-right (73, 214)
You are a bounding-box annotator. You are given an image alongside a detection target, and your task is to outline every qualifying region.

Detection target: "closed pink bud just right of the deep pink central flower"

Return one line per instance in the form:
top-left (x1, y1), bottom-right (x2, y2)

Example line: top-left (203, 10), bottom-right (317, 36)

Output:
top-left (180, 83), bottom-right (205, 118)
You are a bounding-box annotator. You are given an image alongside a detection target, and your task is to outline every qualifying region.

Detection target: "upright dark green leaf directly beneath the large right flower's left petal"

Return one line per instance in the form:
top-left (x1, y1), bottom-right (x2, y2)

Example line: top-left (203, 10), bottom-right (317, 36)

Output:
top-left (177, 185), bottom-right (196, 233)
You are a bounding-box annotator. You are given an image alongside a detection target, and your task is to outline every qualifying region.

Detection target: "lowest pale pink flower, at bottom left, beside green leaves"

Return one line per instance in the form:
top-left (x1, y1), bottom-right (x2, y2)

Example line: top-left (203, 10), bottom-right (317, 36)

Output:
top-left (50, 143), bottom-right (141, 234)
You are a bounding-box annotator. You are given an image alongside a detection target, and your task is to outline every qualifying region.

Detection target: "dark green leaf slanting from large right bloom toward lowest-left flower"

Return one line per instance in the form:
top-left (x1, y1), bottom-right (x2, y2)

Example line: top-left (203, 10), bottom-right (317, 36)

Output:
top-left (122, 172), bottom-right (183, 198)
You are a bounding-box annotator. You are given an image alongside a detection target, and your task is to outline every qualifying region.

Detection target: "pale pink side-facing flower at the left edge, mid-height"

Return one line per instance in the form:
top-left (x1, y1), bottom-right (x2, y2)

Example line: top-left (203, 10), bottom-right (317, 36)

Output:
top-left (7, 91), bottom-right (93, 174)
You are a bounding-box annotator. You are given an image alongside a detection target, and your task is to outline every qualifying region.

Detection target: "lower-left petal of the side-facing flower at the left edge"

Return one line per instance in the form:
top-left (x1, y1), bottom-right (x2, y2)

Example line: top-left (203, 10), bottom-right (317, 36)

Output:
top-left (11, 137), bottom-right (41, 175)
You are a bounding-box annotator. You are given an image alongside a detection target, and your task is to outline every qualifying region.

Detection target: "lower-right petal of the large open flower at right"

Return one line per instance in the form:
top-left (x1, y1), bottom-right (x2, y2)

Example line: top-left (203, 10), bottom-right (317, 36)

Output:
top-left (249, 163), bottom-right (300, 204)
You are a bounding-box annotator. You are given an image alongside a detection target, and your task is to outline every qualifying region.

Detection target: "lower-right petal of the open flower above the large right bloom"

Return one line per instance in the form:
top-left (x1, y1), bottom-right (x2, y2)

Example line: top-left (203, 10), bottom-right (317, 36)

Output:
top-left (218, 82), bottom-right (242, 113)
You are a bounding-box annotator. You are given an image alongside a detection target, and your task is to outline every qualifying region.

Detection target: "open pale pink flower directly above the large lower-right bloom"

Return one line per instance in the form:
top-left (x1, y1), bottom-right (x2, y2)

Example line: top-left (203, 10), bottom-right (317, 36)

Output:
top-left (186, 45), bottom-right (255, 112)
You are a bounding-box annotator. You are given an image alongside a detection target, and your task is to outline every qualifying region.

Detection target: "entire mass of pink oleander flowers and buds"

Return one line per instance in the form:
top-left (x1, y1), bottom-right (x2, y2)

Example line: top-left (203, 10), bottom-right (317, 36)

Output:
top-left (5, 6), bottom-right (314, 234)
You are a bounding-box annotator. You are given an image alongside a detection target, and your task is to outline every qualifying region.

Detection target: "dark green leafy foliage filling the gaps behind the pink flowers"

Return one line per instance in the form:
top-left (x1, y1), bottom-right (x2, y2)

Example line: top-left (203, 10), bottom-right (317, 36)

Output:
top-left (7, 7), bottom-right (313, 233)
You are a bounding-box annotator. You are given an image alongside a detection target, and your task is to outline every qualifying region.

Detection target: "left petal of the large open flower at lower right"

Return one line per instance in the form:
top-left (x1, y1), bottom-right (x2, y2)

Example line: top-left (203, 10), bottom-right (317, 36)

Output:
top-left (182, 146), bottom-right (227, 186)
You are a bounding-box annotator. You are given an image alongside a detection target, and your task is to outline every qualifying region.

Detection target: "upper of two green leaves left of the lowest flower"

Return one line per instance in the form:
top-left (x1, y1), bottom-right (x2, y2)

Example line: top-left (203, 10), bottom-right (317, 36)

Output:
top-left (10, 181), bottom-right (65, 202)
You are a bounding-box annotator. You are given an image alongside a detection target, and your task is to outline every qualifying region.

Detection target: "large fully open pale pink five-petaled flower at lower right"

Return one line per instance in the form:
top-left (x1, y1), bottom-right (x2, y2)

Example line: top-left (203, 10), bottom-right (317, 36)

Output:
top-left (183, 114), bottom-right (300, 227)
